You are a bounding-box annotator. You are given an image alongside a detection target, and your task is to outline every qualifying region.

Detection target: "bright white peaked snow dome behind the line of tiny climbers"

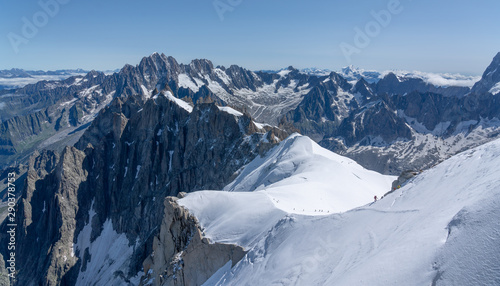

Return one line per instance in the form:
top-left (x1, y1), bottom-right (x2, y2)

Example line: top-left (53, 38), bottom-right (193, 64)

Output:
top-left (224, 134), bottom-right (395, 215)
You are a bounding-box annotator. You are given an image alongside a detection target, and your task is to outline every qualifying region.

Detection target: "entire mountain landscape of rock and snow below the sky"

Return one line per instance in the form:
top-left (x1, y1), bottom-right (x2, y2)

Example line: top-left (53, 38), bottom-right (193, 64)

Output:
top-left (0, 53), bottom-right (500, 285)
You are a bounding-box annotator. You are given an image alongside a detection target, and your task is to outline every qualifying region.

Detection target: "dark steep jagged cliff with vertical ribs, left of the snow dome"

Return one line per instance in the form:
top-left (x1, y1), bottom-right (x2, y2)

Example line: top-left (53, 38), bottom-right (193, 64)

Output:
top-left (2, 90), bottom-right (286, 285)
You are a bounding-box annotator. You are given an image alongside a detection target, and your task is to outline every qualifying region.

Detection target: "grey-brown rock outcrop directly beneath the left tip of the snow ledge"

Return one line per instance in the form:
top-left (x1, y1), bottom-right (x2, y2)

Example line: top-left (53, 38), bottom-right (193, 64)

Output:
top-left (140, 197), bottom-right (246, 286)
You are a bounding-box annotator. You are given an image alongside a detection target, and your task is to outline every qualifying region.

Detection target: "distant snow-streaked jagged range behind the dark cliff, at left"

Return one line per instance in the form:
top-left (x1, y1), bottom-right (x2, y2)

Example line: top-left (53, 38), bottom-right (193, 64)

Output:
top-left (0, 53), bottom-right (308, 168)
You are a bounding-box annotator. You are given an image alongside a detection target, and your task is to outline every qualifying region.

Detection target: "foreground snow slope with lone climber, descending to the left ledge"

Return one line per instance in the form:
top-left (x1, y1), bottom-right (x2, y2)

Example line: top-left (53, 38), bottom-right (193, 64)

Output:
top-left (180, 136), bottom-right (500, 285)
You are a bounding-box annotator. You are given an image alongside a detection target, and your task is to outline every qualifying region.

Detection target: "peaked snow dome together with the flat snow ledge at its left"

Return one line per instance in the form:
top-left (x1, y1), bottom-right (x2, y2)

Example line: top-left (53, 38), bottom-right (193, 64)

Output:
top-left (180, 134), bottom-right (395, 244)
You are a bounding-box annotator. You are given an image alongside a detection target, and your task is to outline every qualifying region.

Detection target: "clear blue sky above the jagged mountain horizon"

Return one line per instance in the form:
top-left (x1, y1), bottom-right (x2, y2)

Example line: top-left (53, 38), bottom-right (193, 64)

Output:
top-left (0, 0), bottom-right (500, 74)
